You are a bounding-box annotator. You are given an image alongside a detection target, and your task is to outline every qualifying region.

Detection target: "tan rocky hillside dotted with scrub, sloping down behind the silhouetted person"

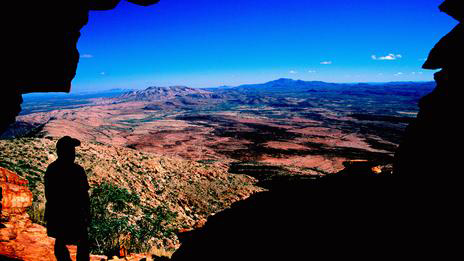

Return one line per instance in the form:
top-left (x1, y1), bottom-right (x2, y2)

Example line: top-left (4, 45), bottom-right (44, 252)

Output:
top-left (0, 138), bottom-right (260, 253)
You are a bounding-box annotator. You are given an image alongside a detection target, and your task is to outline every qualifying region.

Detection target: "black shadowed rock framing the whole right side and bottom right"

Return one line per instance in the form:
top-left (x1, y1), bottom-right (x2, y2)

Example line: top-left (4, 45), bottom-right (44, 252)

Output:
top-left (173, 0), bottom-right (464, 261)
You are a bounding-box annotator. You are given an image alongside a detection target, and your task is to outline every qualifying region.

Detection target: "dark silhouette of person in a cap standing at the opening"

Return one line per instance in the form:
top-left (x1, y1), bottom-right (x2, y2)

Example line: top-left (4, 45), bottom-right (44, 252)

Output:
top-left (45, 136), bottom-right (90, 261)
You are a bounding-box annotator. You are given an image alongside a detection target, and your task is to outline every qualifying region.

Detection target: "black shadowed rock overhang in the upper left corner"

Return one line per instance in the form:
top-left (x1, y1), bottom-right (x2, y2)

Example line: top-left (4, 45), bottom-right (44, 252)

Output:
top-left (0, 0), bottom-right (159, 134)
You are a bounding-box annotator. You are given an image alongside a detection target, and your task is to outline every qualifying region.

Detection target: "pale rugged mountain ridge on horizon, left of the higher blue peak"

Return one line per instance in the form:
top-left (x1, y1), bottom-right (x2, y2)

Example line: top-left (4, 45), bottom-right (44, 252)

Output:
top-left (118, 86), bottom-right (212, 101)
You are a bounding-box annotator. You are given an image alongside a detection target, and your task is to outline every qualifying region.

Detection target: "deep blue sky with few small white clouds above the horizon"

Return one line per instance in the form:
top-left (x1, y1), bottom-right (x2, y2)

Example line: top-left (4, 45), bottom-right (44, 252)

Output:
top-left (73, 0), bottom-right (457, 91)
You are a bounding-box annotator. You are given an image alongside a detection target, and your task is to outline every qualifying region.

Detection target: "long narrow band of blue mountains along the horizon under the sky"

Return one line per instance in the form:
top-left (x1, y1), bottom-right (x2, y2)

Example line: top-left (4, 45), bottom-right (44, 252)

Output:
top-left (117, 78), bottom-right (435, 102)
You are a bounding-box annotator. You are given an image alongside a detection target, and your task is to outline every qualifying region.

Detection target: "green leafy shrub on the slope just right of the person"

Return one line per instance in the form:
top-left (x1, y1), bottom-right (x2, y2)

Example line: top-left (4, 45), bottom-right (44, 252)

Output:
top-left (89, 183), bottom-right (177, 256)
